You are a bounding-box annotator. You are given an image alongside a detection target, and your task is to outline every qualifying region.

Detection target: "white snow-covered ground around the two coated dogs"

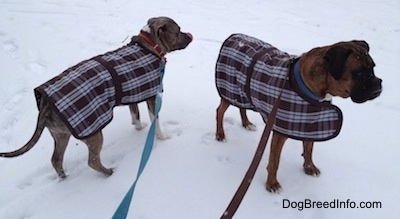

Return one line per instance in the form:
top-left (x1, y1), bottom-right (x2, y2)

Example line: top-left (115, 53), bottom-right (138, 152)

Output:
top-left (0, 0), bottom-right (400, 219)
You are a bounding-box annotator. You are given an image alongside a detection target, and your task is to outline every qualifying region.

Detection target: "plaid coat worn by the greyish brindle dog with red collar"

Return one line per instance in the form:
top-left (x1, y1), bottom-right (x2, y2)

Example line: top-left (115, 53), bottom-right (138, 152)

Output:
top-left (34, 42), bottom-right (164, 139)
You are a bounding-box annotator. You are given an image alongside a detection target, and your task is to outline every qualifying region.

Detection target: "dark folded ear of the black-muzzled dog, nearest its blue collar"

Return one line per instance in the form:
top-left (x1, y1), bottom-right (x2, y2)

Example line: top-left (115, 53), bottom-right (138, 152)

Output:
top-left (324, 45), bottom-right (351, 80)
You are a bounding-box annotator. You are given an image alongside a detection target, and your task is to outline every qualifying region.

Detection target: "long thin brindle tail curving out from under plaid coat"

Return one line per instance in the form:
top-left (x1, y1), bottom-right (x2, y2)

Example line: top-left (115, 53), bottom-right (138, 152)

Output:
top-left (0, 104), bottom-right (49, 157)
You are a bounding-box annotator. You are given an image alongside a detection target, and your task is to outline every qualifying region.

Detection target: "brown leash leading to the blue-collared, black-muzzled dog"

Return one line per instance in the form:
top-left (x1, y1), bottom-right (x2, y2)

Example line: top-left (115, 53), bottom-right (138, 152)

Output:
top-left (221, 64), bottom-right (287, 219)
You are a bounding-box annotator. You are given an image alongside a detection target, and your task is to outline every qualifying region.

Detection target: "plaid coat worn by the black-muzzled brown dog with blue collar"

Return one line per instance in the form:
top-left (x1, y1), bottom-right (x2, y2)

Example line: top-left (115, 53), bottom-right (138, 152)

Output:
top-left (215, 34), bottom-right (342, 141)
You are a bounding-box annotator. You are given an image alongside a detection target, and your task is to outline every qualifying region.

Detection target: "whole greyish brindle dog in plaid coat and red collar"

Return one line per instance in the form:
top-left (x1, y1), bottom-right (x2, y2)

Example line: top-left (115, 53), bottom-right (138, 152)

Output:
top-left (0, 17), bottom-right (192, 178)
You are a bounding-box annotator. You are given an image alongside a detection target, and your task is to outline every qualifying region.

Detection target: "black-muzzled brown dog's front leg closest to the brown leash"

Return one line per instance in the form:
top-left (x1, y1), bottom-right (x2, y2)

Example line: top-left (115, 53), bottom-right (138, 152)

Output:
top-left (266, 132), bottom-right (287, 192)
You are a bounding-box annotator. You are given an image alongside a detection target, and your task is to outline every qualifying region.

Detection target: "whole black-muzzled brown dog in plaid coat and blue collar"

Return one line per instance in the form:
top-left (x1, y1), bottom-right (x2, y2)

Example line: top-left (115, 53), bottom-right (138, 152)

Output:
top-left (216, 34), bottom-right (382, 192)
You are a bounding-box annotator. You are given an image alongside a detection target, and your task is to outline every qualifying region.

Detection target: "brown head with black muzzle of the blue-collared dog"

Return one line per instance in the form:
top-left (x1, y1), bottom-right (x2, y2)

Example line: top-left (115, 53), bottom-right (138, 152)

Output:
top-left (324, 40), bottom-right (382, 103)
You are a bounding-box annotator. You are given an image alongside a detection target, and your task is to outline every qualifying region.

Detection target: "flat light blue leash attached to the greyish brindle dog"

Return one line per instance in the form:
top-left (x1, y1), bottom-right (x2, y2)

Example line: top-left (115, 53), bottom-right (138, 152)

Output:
top-left (112, 62), bottom-right (165, 219)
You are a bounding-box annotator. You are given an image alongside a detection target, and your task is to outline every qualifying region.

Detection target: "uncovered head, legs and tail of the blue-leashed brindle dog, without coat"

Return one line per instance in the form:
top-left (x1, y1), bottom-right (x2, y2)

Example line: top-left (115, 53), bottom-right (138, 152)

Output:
top-left (0, 17), bottom-right (192, 178)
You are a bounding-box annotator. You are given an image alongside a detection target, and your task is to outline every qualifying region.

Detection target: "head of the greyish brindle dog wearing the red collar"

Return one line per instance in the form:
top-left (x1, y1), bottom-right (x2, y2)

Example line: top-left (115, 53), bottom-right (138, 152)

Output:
top-left (142, 17), bottom-right (193, 53)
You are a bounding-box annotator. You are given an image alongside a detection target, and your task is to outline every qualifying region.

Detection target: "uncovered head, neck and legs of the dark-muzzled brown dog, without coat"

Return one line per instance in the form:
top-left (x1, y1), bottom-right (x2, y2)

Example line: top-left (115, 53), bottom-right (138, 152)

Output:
top-left (216, 40), bottom-right (382, 192)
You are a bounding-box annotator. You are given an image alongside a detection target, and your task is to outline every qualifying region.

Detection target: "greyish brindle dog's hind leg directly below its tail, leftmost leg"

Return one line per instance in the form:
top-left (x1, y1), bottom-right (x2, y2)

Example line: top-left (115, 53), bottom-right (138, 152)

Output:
top-left (50, 130), bottom-right (71, 178)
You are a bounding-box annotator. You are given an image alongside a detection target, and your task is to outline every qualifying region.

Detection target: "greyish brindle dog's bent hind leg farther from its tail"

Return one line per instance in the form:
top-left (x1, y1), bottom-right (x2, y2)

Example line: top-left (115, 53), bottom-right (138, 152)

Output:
top-left (83, 131), bottom-right (113, 176)
